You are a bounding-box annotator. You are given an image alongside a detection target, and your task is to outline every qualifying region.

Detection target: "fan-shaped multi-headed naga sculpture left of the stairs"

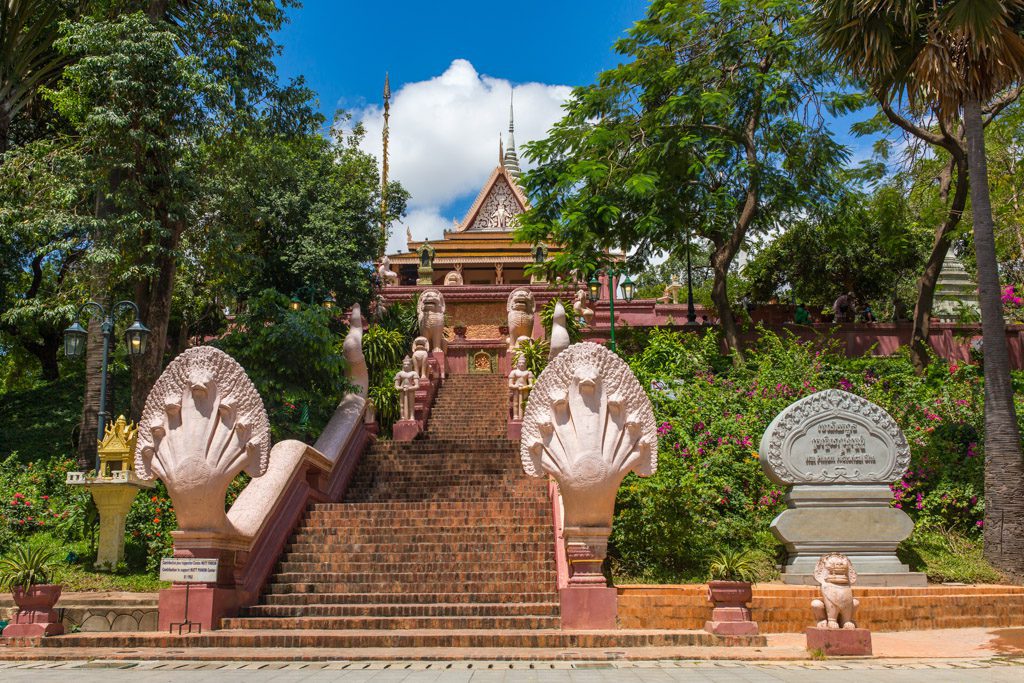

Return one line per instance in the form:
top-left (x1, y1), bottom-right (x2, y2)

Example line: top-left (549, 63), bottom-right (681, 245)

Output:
top-left (135, 346), bottom-right (270, 537)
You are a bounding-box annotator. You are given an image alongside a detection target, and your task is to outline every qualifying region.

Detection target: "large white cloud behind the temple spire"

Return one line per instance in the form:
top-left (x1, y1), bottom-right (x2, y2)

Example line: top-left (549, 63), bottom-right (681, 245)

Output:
top-left (354, 59), bottom-right (571, 252)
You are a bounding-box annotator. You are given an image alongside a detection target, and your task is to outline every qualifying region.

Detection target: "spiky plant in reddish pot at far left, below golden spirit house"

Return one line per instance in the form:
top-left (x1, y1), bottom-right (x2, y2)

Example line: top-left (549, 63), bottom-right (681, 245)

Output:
top-left (0, 545), bottom-right (63, 637)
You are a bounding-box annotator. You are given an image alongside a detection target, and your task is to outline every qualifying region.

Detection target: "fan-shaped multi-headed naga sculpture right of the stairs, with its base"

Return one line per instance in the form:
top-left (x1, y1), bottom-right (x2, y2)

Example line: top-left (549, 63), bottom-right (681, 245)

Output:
top-left (520, 342), bottom-right (657, 586)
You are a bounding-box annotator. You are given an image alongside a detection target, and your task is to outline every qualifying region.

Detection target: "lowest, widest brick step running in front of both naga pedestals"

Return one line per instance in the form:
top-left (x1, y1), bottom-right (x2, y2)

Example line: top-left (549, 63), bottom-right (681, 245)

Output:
top-left (39, 629), bottom-right (767, 649)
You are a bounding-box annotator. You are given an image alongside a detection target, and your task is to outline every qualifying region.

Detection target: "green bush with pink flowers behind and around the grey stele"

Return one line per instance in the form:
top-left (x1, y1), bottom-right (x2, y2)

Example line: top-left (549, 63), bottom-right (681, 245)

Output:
top-left (609, 330), bottom-right (984, 581)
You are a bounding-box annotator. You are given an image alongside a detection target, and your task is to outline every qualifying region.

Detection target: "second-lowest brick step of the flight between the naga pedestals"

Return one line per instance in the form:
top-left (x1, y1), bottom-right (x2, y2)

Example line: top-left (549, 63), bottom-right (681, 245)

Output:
top-left (242, 602), bottom-right (559, 617)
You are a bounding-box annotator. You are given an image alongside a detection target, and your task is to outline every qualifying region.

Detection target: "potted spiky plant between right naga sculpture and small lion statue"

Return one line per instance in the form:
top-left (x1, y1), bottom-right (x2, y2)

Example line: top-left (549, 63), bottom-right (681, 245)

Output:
top-left (705, 549), bottom-right (759, 636)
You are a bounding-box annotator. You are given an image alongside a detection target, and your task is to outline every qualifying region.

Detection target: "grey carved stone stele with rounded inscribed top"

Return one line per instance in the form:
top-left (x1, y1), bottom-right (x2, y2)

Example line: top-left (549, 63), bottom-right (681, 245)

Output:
top-left (760, 389), bottom-right (928, 586)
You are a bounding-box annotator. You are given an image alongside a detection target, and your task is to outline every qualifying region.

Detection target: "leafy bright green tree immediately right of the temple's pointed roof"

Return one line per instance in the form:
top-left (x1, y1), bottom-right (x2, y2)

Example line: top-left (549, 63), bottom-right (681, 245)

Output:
top-left (518, 0), bottom-right (857, 358)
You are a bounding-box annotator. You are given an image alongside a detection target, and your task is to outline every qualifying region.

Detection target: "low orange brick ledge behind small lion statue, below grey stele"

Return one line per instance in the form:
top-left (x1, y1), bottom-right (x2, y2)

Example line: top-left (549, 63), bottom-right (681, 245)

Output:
top-left (618, 584), bottom-right (1024, 634)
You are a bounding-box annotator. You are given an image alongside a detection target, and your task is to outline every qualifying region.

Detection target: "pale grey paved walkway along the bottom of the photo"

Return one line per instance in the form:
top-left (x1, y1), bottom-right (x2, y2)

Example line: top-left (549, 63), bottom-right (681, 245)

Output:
top-left (0, 658), bottom-right (1024, 683)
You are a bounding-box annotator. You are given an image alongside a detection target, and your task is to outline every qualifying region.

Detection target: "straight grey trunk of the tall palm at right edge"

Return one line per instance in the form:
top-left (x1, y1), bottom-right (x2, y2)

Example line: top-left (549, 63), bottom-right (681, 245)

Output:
top-left (964, 100), bottom-right (1024, 577)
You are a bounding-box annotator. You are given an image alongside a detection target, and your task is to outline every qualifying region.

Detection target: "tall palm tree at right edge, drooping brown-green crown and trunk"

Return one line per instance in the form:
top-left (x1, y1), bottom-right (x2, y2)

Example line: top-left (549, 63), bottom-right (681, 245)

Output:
top-left (815, 0), bottom-right (1024, 575)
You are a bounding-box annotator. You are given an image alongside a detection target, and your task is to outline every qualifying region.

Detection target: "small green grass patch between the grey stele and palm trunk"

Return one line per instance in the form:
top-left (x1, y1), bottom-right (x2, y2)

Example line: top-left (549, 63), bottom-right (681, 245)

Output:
top-left (897, 528), bottom-right (1007, 584)
